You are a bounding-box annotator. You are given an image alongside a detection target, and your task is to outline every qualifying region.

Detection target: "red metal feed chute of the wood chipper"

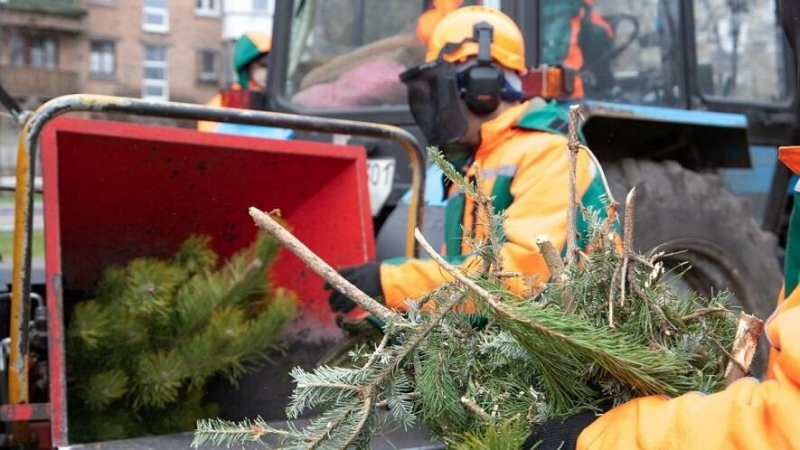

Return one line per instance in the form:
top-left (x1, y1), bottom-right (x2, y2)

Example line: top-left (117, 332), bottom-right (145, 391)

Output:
top-left (41, 118), bottom-right (374, 432)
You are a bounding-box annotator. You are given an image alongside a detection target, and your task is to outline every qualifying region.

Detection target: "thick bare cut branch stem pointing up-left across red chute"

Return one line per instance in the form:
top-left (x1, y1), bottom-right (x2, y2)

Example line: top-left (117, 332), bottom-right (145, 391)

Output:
top-left (249, 207), bottom-right (400, 322)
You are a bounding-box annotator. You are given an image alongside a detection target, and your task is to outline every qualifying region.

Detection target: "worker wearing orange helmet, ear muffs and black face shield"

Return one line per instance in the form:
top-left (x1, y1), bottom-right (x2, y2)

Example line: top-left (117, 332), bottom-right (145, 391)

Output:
top-left (329, 6), bottom-right (608, 313)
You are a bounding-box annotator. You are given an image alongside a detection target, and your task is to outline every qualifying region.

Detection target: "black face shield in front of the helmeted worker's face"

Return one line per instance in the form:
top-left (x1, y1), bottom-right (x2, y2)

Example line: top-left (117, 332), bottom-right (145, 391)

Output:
top-left (400, 60), bottom-right (467, 147)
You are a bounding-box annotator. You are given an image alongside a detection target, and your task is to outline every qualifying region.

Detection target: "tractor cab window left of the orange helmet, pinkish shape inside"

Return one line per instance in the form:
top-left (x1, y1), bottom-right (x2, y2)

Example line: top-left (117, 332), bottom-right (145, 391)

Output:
top-left (286, 0), bottom-right (425, 110)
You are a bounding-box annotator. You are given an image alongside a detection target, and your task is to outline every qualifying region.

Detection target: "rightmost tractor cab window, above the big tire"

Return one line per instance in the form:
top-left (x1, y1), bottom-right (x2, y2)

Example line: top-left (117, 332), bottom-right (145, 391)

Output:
top-left (694, 0), bottom-right (788, 102)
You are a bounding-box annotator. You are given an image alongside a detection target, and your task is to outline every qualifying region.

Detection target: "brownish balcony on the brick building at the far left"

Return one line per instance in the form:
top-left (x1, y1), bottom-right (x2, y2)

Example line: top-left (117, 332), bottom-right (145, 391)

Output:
top-left (0, 65), bottom-right (80, 98)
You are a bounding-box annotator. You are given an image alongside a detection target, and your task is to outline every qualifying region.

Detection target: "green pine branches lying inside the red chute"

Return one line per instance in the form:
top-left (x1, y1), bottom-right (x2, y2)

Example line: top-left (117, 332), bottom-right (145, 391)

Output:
top-left (67, 234), bottom-right (296, 442)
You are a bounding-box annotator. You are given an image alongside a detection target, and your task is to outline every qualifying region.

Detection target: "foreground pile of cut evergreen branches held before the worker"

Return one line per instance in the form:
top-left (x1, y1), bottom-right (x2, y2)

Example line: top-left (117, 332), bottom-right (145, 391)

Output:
top-left (193, 125), bottom-right (737, 449)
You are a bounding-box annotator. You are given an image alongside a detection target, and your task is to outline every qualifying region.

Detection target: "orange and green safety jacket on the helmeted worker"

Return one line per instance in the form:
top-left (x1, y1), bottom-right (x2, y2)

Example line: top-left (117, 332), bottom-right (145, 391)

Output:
top-left (380, 102), bottom-right (609, 311)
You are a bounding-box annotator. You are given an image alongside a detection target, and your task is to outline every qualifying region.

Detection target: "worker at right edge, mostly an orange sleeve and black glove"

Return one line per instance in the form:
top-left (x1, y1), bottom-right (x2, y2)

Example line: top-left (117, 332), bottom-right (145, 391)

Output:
top-left (523, 147), bottom-right (800, 450)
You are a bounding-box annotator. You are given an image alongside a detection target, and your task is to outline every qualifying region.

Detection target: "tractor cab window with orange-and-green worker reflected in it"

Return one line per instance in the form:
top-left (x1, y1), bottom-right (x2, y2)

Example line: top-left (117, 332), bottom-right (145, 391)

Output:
top-left (540, 0), bottom-right (686, 106)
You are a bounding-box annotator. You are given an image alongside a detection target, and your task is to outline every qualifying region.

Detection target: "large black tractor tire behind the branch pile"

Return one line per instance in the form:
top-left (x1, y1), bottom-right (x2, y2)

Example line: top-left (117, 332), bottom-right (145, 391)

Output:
top-left (603, 159), bottom-right (782, 377)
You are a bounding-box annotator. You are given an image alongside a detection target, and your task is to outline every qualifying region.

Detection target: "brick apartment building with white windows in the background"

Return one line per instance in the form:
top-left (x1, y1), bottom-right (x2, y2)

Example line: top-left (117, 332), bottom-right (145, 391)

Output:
top-left (0, 0), bottom-right (230, 172)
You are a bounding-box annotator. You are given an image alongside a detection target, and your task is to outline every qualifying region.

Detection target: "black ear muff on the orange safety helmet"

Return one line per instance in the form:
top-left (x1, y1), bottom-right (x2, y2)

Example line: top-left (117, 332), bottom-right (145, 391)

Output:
top-left (461, 22), bottom-right (505, 115)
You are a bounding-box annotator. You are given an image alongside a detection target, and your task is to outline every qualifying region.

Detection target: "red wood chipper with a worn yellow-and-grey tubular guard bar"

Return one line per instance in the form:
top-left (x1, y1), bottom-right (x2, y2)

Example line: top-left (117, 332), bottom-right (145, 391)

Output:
top-left (0, 95), bottom-right (438, 448)
